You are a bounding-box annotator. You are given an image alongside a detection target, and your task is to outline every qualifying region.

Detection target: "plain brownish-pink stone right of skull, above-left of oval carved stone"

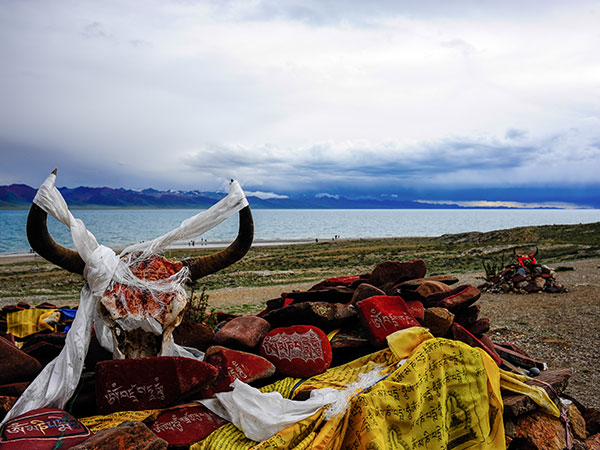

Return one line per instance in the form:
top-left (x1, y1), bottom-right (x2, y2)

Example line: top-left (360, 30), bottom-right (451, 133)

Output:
top-left (213, 316), bottom-right (271, 350)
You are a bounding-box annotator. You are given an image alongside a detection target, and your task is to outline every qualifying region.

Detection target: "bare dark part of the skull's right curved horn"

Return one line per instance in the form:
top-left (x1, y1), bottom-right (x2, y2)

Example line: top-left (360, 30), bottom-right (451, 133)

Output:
top-left (181, 206), bottom-right (254, 281)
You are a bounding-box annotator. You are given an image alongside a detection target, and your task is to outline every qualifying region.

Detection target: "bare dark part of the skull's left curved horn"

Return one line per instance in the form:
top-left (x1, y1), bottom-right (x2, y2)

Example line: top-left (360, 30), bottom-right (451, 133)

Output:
top-left (27, 203), bottom-right (85, 275)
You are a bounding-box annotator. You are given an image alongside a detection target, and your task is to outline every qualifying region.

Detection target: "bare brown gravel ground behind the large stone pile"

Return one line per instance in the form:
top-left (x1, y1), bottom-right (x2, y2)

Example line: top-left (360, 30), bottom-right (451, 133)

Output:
top-left (209, 260), bottom-right (600, 409)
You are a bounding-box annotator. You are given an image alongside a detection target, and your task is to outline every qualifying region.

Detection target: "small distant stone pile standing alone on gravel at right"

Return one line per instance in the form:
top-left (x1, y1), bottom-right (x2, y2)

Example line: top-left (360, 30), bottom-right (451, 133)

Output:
top-left (478, 262), bottom-right (567, 294)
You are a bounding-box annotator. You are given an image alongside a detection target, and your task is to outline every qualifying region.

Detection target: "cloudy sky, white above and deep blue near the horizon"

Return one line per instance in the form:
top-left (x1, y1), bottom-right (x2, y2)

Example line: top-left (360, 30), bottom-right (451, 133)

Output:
top-left (0, 0), bottom-right (600, 205)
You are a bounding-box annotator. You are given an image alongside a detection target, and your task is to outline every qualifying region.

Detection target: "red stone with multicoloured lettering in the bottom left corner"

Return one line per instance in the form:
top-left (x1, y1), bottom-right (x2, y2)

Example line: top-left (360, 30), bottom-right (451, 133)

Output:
top-left (0, 408), bottom-right (92, 450)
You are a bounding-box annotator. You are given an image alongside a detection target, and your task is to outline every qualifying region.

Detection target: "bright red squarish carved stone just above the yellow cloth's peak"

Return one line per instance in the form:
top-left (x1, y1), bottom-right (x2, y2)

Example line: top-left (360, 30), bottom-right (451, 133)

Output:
top-left (356, 295), bottom-right (421, 347)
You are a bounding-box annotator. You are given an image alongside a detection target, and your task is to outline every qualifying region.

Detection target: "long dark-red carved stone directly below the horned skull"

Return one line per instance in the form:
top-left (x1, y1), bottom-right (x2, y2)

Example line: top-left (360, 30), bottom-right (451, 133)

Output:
top-left (96, 356), bottom-right (217, 414)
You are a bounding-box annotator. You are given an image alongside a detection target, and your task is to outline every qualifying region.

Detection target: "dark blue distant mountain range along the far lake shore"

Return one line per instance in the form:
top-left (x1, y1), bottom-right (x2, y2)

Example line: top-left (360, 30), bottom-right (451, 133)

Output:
top-left (0, 184), bottom-right (556, 209)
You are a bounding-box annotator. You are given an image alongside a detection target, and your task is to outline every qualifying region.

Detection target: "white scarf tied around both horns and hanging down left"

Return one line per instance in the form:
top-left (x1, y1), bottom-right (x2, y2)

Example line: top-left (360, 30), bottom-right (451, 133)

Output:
top-left (2, 174), bottom-right (248, 423)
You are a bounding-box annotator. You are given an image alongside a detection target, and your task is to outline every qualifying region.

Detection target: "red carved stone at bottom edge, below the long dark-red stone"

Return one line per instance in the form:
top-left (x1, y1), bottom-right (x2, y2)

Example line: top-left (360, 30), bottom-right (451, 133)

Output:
top-left (150, 405), bottom-right (227, 448)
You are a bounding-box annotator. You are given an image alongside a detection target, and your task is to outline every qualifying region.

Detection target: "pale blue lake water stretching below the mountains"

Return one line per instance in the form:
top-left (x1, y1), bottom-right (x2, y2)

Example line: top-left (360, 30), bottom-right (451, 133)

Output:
top-left (0, 209), bottom-right (600, 254)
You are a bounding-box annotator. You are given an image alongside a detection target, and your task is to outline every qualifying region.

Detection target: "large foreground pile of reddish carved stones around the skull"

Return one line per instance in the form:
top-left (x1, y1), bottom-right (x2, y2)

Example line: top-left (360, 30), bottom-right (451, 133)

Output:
top-left (0, 259), bottom-right (600, 450)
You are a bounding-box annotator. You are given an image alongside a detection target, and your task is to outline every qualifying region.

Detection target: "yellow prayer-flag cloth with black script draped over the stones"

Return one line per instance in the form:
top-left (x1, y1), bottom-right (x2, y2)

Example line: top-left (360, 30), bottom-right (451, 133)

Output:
top-left (191, 328), bottom-right (555, 450)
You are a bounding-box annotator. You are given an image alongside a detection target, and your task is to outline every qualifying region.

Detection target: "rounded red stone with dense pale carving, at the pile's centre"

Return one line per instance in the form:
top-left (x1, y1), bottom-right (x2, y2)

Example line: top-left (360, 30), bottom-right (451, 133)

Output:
top-left (260, 325), bottom-right (333, 378)
